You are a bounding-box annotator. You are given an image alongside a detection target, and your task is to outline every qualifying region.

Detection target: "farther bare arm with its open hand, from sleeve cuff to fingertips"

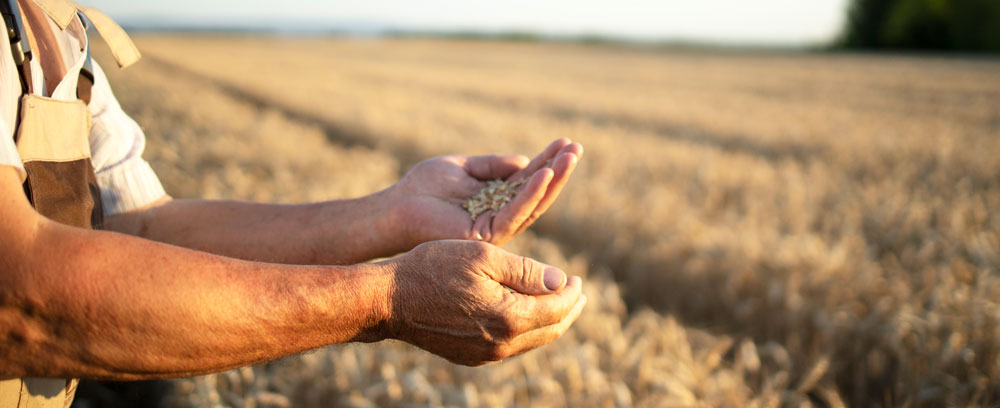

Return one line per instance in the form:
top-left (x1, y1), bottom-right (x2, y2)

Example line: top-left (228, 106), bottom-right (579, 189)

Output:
top-left (105, 139), bottom-right (583, 265)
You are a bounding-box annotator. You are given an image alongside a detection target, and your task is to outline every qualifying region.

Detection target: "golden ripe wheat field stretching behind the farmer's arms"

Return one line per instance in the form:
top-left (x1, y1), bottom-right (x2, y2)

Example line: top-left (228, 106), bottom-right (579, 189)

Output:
top-left (90, 35), bottom-right (1000, 407)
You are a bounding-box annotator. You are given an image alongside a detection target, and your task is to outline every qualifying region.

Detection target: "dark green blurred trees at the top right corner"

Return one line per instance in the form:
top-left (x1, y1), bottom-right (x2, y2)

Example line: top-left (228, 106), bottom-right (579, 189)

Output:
top-left (840, 0), bottom-right (1000, 52)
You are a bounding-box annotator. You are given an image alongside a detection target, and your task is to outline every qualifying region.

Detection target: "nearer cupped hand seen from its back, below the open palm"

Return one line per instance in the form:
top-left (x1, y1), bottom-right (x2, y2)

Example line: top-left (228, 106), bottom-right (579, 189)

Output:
top-left (384, 241), bottom-right (587, 366)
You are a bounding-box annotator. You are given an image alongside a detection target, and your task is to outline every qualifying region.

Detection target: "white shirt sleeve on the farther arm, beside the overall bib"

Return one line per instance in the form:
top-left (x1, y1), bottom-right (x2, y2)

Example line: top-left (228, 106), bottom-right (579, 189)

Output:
top-left (89, 61), bottom-right (166, 215)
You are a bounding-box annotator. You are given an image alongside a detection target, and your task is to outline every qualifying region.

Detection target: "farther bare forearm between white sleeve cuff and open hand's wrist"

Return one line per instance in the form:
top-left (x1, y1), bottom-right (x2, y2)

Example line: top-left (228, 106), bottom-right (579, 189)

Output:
top-left (106, 188), bottom-right (408, 265)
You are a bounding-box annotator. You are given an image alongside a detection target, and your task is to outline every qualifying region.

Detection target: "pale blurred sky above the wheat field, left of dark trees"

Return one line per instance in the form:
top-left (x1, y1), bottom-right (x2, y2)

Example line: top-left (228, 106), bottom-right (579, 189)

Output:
top-left (79, 0), bottom-right (848, 46)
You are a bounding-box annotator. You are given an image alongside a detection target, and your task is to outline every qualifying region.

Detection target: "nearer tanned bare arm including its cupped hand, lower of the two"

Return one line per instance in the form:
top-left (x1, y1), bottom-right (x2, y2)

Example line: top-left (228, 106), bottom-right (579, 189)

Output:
top-left (0, 166), bottom-right (586, 379)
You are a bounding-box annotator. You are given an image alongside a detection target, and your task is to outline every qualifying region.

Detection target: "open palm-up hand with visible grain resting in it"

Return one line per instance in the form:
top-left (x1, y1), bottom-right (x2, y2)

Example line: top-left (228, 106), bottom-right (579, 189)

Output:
top-left (392, 138), bottom-right (583, 245)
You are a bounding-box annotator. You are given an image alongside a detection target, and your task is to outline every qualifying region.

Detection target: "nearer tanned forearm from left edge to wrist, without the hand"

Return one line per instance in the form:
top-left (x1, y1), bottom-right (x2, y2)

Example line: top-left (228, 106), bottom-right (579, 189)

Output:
top-left (0, 220), bottom-right (391, 379)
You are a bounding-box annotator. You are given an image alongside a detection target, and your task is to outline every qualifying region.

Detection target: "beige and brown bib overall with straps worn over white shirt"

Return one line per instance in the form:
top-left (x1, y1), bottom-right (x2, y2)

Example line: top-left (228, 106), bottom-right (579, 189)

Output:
top-left (0, 0), bottom-right (139, 408)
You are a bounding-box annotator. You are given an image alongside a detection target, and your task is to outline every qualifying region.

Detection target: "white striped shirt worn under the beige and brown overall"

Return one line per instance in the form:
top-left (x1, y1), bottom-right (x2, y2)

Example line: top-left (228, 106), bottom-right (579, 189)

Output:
top-left (0, 7), bottom-right (166, 215)
